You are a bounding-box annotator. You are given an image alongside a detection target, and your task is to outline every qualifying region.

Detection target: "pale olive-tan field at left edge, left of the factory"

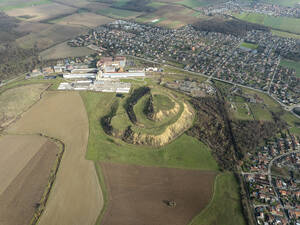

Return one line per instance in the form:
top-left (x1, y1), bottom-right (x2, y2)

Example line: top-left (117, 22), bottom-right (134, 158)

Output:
top-left (0, 84), bottom-right (49, 129)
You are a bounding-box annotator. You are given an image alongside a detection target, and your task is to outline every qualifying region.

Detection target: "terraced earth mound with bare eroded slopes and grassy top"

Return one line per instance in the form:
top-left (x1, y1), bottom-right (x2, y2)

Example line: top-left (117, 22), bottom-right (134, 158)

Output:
top-left (101, 87), bottom-right (195, 147)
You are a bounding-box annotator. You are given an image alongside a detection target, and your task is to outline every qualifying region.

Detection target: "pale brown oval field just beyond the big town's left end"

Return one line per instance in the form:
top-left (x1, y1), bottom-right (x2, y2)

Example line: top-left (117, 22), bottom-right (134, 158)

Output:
top-left (56, 13), bottom-right (113, 28)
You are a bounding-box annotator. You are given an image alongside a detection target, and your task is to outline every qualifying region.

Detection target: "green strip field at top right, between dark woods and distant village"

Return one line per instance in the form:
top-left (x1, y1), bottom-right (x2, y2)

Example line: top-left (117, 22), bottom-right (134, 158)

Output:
top-left (235, 13), bottom-right (300, 34)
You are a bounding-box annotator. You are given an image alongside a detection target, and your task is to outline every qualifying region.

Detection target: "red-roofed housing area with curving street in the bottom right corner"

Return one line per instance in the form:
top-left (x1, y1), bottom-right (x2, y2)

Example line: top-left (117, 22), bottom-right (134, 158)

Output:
top-left (242, 134), bottom-right (300, 224)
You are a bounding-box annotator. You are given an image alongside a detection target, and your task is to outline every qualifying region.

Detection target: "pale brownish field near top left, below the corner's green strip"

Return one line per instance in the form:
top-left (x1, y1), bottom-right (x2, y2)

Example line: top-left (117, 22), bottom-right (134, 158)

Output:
top-left (7, 3), bottom-right (77, 21)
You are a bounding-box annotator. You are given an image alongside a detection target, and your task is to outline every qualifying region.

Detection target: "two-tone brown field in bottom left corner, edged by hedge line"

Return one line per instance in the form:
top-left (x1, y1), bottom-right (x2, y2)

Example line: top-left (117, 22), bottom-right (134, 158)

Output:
top-left (0, 135), bottom-right (59, 225)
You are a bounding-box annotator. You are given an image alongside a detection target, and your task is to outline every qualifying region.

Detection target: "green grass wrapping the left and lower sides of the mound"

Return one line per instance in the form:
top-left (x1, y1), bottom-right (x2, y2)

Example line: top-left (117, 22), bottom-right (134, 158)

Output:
top-left (81, 92), bottom-right (218, 171)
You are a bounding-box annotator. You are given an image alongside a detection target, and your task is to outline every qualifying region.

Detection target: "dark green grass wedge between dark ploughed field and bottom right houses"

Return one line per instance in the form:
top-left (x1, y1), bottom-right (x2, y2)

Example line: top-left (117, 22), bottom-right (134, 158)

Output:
top-left (190, 173), bottom-right (246, 225)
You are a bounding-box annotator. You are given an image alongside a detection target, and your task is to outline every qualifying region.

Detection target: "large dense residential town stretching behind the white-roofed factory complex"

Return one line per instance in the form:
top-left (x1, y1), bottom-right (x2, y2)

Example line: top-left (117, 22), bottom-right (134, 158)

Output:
top-left (69, 20), bottom-right (300, 106)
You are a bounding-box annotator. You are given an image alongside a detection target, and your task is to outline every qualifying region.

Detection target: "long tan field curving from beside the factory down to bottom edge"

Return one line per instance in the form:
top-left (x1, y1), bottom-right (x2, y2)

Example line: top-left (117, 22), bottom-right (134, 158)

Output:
top-left (8, 92), bottom-right (103, 225)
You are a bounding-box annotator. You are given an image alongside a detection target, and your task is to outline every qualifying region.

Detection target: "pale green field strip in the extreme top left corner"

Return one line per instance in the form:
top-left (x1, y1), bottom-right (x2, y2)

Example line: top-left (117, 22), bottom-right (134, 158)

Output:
top-left (0, 0), bottom-right (51, 11)
